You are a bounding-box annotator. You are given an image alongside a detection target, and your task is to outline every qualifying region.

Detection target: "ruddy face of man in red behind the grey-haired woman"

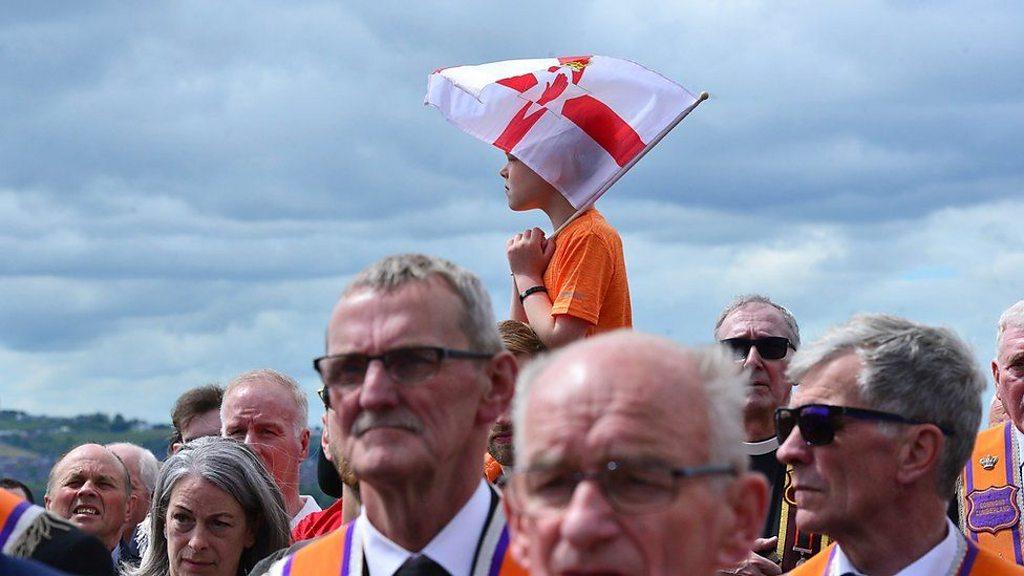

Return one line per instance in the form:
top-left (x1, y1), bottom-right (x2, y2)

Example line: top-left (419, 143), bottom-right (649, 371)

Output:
top-left (223, 381), bottom-right (309, 499)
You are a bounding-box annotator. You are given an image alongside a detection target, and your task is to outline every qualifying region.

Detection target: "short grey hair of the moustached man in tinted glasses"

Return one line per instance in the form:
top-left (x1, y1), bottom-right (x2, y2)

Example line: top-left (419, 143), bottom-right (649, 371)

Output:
top-left (342, 254), bottom-right (502, 354)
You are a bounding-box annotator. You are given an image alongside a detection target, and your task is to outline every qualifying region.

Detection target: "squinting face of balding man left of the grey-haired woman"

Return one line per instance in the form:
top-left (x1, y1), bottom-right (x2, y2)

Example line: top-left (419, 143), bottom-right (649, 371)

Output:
top-left (43, 444), bottom-right (132, 549)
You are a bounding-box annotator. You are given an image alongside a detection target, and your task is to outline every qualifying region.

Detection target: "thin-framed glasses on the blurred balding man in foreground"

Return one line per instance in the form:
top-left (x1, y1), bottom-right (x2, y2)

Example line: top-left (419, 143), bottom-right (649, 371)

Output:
top-left (508, 460), bottom-right (737, 515)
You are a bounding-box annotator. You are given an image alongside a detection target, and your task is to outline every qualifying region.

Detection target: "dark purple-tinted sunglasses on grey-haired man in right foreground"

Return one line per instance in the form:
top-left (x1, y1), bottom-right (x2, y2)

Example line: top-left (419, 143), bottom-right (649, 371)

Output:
top-left (775, 404), bottom-right (953, 446)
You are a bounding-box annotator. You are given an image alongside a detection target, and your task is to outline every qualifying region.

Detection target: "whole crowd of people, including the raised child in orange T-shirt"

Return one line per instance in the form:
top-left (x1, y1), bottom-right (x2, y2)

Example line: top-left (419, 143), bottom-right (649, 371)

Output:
top-left (0, 156), bottom-right (1024, 576)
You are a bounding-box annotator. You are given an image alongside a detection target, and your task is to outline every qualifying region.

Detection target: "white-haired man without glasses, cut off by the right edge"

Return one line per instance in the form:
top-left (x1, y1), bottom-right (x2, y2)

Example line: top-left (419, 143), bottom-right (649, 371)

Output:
top-left (957, 300), bottom-right (1024, 564)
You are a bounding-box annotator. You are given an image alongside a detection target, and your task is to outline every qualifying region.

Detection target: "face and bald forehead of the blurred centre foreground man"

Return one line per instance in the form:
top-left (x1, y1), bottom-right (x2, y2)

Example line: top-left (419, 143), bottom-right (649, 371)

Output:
top-left (509, 342), bottom-right (766, 576)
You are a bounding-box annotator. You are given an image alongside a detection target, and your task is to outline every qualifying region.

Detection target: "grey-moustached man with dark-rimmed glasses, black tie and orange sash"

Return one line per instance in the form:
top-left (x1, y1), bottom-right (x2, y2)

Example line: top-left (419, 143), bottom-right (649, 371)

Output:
top-left (271, 254), bottom-right (523, 576)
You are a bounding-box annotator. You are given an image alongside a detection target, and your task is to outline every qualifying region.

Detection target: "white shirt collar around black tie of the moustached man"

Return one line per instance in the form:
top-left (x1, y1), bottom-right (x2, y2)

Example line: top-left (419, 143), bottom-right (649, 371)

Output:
top-left (354, 481), bottom-right (490, 576)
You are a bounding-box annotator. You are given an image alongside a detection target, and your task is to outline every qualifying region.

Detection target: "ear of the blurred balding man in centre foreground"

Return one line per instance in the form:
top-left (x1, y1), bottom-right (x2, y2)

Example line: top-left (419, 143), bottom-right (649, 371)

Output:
top-left (718, 472), bottom-right (768, 566)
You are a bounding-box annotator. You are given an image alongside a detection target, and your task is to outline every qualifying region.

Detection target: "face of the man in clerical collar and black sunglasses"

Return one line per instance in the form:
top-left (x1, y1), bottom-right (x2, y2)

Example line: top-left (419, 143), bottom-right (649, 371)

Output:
top-left (718, 302), bottom-right (793, 442)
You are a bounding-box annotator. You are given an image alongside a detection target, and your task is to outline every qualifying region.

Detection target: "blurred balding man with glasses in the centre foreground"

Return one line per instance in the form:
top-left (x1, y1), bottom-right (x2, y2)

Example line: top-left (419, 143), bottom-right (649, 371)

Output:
top-left (506, 331), bottom-right (768, 576)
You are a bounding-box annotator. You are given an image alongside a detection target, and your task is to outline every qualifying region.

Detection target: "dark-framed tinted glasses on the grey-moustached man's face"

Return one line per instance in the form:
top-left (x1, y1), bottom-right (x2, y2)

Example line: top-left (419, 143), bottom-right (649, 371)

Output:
top-left (313, 346), bottom-right (494, 408)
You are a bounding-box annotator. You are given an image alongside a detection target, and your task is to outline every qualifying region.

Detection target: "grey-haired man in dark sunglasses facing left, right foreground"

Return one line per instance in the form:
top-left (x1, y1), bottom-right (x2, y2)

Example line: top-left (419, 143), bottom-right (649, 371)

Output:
top-left (775, 315), bottom-right (1024, 576)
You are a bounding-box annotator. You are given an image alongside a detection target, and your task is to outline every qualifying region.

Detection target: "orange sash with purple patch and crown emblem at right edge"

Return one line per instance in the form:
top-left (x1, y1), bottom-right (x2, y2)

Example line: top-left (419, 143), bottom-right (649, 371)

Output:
top-left (956, 422), bottom-right (1024, 565)
